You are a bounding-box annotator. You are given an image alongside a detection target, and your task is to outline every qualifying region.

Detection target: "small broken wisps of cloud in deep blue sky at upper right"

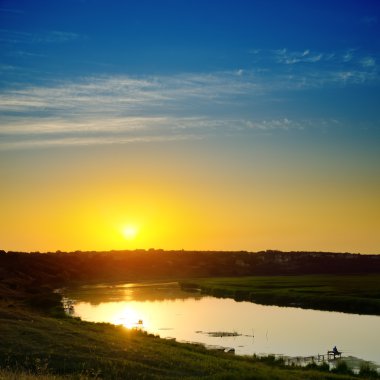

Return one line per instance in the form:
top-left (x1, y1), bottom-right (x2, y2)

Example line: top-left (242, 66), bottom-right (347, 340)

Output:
top-left (250, 48), bottom-right (380, 90)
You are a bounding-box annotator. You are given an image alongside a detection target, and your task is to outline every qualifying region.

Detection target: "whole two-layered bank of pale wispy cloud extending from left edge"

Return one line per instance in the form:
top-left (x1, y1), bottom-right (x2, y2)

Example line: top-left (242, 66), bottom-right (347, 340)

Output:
top-left (0, 72), bottom-right (334, 150)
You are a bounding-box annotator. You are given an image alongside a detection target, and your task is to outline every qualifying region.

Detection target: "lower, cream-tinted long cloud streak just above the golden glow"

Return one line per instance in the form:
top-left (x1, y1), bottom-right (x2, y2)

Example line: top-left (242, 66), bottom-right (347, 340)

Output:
top-left (0, 116), bottom-right (336, 151)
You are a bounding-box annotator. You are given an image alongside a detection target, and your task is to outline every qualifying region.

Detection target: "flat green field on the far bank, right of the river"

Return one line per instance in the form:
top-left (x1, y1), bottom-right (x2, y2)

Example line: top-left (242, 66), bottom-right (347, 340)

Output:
top-left (181, 275), bottom-right (380, 315)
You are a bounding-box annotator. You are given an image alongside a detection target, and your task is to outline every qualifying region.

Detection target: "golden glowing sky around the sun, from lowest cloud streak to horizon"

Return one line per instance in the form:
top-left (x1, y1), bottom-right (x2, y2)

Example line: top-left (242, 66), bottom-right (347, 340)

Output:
top-left (0, 139), bottom-right (380, 253)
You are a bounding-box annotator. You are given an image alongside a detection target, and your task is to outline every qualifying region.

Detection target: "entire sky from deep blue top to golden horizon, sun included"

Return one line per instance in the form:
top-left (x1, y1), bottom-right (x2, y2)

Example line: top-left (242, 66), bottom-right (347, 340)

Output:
top-left (0, 0), bottom-right (380, 253)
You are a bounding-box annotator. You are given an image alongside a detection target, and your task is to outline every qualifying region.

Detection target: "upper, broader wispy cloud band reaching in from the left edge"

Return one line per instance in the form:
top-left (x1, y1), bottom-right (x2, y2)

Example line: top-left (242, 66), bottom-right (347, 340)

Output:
top-left (0, 72), bottom-right (259, 117)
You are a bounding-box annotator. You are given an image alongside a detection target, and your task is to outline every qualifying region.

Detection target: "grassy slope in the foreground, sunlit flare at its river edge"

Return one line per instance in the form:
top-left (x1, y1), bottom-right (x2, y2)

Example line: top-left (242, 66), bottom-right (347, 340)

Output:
top-left (0, 305), bottom-right (366, 380)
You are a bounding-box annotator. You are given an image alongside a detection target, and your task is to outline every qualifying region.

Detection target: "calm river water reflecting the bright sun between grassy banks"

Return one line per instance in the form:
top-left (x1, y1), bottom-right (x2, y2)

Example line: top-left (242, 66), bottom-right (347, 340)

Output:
top-left (65, 283), bottom-right (380, 365)
